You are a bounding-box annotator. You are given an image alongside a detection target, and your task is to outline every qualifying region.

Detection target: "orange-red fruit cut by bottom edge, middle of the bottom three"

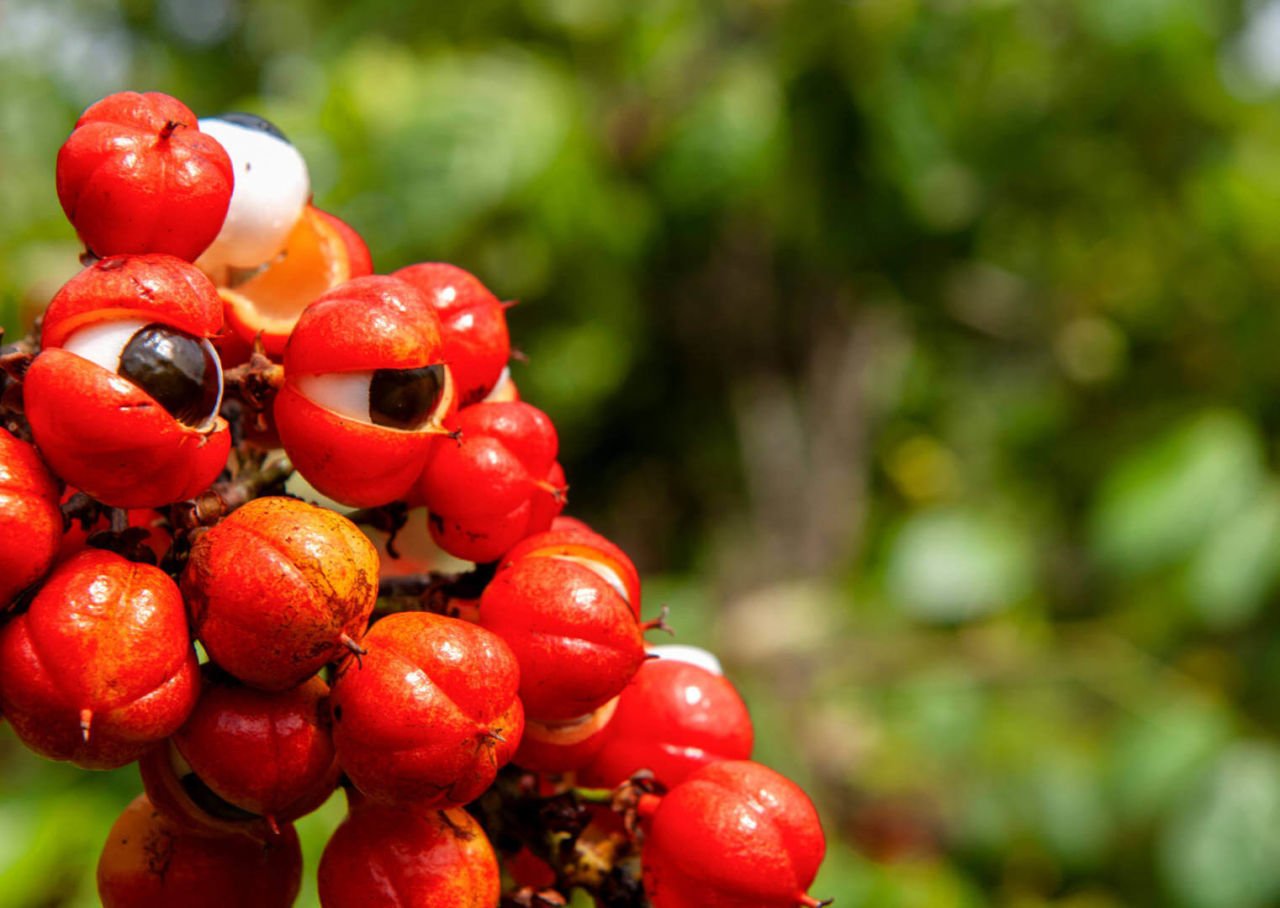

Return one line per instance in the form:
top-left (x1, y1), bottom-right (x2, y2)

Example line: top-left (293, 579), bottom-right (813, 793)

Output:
top-left (319, 804), bottom-right (500, 908)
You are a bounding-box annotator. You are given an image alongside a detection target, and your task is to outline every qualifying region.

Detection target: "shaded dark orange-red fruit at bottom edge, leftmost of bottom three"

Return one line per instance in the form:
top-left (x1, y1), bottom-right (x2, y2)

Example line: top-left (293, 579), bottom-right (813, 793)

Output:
top-left (97, 794), bottom-right (302, 908)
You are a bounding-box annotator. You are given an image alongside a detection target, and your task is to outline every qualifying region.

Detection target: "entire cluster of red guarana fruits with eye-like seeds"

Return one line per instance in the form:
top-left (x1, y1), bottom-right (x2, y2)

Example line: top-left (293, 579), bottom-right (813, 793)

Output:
top-left (0, 92), bottom-right (824, 908)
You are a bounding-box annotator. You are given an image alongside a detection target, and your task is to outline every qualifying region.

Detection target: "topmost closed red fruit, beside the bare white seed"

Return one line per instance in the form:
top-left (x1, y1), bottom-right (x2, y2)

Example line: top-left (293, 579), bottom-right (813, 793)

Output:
top-left (58, 91), bottom-right (234, 261)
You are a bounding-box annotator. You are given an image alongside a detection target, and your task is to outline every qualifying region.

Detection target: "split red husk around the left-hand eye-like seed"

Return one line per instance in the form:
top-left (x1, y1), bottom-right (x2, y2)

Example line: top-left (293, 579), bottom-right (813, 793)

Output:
top-left (23, 255), bottom-right (230, 508)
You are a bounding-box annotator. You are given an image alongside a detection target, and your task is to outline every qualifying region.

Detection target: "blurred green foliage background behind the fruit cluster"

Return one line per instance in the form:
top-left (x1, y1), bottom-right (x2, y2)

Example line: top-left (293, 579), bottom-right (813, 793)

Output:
top-left (0, 0), bottom-right (1280, 908)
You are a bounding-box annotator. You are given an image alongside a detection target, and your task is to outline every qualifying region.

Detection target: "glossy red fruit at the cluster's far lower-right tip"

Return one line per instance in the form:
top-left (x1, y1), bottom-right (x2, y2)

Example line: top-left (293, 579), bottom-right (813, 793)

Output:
top-left (640, 761), bottom-right (827, 908)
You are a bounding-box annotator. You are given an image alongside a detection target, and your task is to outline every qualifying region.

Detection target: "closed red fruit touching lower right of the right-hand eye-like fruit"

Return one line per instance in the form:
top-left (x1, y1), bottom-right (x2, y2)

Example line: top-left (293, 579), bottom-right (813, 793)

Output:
top-left (417, 402), bottom-right (564, 562)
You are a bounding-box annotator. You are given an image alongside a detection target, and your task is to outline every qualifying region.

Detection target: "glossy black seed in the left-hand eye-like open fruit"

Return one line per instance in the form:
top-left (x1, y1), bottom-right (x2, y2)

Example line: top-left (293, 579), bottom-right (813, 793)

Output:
top-left (116, 325), bottom-right (220, 425)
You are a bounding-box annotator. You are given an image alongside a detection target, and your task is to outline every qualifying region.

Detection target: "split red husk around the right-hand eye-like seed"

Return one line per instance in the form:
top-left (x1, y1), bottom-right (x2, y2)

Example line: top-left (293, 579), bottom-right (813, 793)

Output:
top-left (274, 275), bottom-right (453, 507)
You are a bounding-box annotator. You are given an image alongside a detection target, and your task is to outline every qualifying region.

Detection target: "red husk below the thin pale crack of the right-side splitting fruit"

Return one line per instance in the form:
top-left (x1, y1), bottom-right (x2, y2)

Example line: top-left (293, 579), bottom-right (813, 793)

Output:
top-left (480, 548), bottom-right (644, 721)
